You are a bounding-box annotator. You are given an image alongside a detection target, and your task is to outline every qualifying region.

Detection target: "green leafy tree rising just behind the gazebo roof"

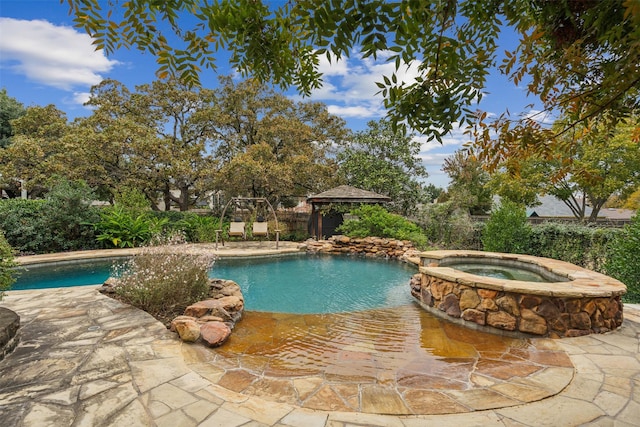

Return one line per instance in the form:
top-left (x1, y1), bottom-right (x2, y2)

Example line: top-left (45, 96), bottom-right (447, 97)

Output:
top-left (337, 120), bottom-right (428, 215)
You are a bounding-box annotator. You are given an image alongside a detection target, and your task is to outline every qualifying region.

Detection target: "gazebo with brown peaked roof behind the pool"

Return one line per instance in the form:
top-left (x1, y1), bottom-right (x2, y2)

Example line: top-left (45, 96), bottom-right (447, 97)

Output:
top-left (307, 185), bottom-right (391, 240)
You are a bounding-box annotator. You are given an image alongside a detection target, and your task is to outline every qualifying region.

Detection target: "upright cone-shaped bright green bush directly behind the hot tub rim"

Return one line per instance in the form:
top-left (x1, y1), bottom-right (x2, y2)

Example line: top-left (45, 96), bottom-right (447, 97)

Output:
top-left (482, 200), bottom-right (531, 254)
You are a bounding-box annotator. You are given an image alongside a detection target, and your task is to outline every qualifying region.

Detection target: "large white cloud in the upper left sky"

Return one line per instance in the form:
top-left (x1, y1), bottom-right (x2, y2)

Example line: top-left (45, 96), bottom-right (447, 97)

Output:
top-left (0, 18), bottom-right (118, 91)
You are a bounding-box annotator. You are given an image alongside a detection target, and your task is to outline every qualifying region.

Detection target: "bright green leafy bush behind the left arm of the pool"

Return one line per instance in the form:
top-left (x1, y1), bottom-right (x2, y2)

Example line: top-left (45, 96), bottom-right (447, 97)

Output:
top-left (95, 205), bottom-right (168, 248)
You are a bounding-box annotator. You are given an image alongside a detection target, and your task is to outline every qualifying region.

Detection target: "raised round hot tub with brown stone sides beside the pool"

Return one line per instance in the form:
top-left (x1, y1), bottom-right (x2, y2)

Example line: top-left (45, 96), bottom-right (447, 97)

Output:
top-left (411, 251), bottom-right (627, 338)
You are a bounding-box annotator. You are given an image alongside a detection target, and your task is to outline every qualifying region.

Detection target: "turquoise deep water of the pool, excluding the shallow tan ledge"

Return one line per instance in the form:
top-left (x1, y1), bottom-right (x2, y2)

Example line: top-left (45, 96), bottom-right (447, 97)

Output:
top-left (12, 256), bottom-right (416, 313)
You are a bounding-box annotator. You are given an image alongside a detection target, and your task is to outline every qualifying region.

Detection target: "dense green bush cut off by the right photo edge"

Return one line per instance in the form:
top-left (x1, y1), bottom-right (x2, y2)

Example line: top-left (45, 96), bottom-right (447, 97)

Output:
top-left (605, 213), bottom-right (640, 303)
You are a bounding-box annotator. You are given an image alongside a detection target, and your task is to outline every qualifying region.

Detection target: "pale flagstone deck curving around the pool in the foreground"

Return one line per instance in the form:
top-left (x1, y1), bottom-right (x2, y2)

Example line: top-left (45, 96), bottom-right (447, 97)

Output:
top-left (0, 249), bottom-right (640, 427)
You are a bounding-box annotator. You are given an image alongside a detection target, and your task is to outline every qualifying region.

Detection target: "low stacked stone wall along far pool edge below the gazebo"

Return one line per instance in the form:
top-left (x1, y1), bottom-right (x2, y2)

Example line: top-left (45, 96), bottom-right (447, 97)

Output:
top-left (306, 236), bottom-right (420, 264)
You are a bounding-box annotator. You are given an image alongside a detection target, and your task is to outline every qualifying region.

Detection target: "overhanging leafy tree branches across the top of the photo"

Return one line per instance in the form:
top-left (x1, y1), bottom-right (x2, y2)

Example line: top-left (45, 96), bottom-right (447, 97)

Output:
top-left (63, 0), bottom-right (640, 157)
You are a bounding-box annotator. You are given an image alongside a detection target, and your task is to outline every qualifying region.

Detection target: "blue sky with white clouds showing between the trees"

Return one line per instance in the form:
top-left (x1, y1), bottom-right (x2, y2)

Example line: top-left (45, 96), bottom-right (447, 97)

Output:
top-left (0, 0), bottom-right (535, 187)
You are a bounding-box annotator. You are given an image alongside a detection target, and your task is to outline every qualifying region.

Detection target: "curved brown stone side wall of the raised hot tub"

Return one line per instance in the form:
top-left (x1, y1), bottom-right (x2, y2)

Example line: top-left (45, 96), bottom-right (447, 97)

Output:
top-left (411, 274), bottom-right (623, 338)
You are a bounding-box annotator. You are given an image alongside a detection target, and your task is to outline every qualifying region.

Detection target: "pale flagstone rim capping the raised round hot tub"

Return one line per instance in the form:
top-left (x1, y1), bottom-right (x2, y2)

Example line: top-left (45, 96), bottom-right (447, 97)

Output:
top-left (420, 250), bottom-right (627, 298)
